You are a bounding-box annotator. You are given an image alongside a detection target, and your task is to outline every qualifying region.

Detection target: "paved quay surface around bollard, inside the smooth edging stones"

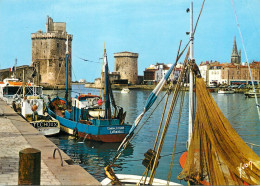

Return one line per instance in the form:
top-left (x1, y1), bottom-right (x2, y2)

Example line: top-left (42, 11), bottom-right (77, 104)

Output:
top-left (0, 117), bottom-right (61, 185)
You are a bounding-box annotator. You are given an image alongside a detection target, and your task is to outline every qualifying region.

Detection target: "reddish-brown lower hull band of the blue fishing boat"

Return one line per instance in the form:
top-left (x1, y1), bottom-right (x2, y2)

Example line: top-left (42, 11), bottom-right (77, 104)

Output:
top-left (78, 132), bottom-right (126, 143)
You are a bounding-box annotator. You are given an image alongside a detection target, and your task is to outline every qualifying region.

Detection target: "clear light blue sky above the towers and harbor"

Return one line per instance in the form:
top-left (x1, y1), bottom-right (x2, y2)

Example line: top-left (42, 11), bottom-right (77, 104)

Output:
top-left (0, 0), bottom-right (260, 82)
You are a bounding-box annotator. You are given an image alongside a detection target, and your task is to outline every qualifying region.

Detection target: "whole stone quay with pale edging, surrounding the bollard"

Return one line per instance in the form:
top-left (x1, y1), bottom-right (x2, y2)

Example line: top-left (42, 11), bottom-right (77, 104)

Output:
top-left (0, 100), bottom-right (100, 185)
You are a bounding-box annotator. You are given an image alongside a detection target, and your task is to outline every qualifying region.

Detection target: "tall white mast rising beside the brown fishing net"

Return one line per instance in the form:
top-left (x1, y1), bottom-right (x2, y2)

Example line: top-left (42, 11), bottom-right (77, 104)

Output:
top-left (188, 1), bottom-right (194, 147)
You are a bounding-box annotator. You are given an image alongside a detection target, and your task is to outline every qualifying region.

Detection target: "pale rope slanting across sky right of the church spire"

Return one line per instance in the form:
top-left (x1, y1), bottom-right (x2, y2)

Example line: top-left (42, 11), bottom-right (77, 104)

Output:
top-left (231, 0), bottom-right (260, 120)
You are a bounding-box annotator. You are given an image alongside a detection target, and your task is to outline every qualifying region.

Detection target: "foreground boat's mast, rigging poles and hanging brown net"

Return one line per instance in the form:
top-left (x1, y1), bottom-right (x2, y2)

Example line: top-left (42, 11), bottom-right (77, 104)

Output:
top-left (102, 1), bottom-right (260, 185)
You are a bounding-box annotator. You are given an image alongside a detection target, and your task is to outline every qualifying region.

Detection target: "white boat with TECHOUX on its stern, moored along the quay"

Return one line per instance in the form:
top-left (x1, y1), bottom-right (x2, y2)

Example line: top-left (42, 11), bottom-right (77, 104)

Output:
top-left (7, 70), bottom-right (60, 136)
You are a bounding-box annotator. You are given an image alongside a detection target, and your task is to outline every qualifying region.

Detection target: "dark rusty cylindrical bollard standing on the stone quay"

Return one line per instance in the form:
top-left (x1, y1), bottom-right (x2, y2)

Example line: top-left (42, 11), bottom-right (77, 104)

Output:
top-left (18, 148), bottom-right (41, 185)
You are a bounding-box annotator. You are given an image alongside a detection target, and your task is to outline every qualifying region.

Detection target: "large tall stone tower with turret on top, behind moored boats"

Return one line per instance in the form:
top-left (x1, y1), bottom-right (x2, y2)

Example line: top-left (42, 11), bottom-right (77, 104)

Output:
top-left (31, 16), bottom-right (72, 89)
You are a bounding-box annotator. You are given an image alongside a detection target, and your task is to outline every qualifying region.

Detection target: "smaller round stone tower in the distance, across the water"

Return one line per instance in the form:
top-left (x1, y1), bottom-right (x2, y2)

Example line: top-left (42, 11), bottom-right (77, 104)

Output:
top-left (114, 52), bottom-right (138, 84)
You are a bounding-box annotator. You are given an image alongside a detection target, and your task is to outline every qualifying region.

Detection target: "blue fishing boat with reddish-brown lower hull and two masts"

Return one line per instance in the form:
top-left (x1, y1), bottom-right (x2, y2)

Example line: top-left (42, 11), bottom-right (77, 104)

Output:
top-left (47, 39), bottom-right (131, 142)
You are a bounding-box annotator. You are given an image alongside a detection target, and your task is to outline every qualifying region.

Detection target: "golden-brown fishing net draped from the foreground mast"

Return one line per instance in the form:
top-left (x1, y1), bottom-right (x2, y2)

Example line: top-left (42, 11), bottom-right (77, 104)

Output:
top-left (178, 78), bottom-right (260, 185)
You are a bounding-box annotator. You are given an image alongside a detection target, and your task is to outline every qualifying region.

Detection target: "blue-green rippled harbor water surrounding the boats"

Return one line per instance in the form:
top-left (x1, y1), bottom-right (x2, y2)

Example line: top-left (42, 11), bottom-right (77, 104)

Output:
top-left (44, 85), bottom-right (260, 184)
